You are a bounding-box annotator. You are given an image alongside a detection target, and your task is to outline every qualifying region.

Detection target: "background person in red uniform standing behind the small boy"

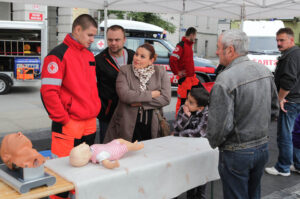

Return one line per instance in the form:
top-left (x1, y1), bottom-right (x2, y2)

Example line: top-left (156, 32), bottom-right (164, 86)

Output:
top-left (170, 27), bottom-right (201, 115)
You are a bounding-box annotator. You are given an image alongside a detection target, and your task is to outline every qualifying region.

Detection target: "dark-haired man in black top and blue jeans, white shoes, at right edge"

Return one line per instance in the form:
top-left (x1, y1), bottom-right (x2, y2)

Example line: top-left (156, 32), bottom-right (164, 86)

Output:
top-left (266, 28), bottom-right (300, 176)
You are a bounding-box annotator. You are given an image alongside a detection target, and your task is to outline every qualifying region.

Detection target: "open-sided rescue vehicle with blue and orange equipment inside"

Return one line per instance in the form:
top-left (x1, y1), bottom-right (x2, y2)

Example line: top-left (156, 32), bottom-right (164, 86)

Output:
top-left (0, 21), bottom-right (47, 95)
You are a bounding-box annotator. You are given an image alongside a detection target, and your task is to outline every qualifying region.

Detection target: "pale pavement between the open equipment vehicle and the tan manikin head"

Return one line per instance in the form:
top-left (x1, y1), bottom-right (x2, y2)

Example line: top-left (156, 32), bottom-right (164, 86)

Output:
top-left (0, 81), bottom-right (51, 135)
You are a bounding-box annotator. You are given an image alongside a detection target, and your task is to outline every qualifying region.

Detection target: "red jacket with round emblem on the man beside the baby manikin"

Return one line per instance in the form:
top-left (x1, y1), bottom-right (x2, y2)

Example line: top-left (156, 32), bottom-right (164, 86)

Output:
top-left (40, 34), bottom-right (101, 124)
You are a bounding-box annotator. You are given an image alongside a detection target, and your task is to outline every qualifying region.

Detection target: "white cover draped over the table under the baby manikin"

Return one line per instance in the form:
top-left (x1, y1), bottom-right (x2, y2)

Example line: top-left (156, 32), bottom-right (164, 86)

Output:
top-left (45, 136), bottom-right (219, 199)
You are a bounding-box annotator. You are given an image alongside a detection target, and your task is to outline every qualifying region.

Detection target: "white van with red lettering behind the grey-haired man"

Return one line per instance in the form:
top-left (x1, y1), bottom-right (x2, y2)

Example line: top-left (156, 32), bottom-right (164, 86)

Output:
top-left (243, 20), bottom-right (284, 72)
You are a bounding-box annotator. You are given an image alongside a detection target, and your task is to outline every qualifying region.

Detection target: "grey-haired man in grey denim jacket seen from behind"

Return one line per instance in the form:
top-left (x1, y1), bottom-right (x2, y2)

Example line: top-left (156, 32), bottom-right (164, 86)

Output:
top-left (207, 30), bottom-right (279, 199)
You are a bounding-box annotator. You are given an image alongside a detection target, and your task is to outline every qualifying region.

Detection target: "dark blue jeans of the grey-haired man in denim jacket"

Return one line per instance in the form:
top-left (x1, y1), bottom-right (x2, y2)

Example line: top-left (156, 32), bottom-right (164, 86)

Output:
top-left (219, 143), bottom-right (269, 199)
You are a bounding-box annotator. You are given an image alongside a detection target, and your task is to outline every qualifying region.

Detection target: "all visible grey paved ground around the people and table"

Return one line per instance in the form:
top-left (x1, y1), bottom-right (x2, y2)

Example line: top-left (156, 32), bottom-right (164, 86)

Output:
top-left (0, 82), bottom-right (300, 199)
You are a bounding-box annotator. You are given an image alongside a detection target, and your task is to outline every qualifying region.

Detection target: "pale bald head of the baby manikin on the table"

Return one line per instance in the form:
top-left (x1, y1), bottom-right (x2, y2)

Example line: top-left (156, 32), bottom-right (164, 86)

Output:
top-left (69, 143), bottom-right (92, 167)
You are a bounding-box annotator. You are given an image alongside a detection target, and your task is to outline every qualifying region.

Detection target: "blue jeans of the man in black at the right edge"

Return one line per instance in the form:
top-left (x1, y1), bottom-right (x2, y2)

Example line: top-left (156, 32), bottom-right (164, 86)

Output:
top-left (275, 102), bottom-right (300, 173)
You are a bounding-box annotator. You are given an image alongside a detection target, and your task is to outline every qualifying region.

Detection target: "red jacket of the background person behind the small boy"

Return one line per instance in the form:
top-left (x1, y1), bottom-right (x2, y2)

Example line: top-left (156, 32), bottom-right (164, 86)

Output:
top-left (170, 37), bottom-right (195, 77)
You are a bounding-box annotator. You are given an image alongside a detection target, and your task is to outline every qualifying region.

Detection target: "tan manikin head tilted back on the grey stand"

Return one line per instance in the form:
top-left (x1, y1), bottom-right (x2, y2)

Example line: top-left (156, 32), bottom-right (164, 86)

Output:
top-left (0, 132), bottom-right (46, 169)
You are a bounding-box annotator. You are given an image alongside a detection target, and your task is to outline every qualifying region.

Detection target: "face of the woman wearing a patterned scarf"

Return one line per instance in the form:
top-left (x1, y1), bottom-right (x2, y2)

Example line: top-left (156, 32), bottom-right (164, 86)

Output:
top-left (133, 47), bottom-right (154, 68)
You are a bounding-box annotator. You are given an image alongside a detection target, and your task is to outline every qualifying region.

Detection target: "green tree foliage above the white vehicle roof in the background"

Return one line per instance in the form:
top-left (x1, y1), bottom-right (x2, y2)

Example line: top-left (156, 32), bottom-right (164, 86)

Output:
top-left (101, 10), bottom-right (176, 33)
